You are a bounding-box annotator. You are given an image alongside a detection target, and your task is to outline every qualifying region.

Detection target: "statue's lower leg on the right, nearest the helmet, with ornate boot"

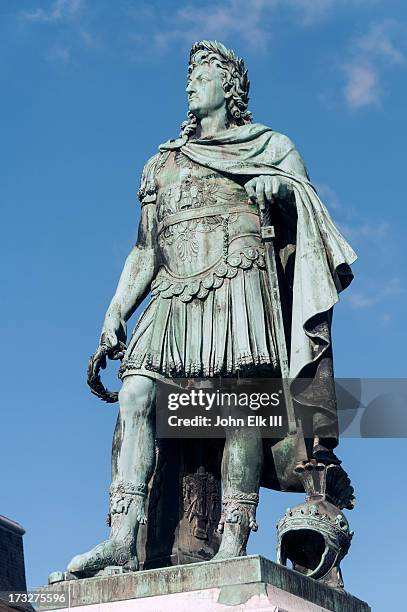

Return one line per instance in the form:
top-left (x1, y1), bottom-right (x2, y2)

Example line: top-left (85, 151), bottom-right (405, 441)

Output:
top-left (214, 429), bottom-right (263, 560)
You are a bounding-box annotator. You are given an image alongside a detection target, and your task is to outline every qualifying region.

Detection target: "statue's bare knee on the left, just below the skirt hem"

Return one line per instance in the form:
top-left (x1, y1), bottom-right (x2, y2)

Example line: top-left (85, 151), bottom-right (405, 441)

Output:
top-left (119, 376), bottom-right (154, 418)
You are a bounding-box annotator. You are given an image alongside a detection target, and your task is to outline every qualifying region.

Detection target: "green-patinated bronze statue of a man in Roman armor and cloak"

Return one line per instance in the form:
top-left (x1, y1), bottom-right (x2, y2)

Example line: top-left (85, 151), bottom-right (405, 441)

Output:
top-left (61, 41), bottom-right (356, 578)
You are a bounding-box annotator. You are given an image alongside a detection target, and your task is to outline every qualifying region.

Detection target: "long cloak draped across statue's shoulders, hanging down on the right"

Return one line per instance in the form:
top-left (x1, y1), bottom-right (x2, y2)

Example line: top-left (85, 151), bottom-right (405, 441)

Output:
top-left (159, 123), bottom-right (356, 454)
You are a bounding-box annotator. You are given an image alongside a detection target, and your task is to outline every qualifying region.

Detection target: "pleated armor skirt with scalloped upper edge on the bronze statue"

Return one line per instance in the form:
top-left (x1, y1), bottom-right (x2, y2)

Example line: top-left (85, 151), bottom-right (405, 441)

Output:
top-left (119, 247), bottom-right (278, 378)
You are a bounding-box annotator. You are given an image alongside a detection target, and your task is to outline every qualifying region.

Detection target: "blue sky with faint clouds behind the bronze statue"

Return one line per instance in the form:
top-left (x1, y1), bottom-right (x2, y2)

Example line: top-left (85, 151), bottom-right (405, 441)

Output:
top-left (0, 0), bottom-right (407, 611)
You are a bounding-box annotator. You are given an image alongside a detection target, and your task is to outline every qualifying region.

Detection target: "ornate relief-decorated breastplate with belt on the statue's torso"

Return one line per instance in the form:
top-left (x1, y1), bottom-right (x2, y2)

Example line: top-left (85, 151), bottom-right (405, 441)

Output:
top-left (157, 152), bottom-right (259, 278)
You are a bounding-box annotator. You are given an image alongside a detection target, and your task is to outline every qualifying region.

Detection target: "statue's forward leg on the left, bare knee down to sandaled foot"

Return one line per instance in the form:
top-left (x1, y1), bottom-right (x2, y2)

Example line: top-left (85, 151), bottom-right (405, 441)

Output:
top-left (68, 375), bottom-right (156, 577)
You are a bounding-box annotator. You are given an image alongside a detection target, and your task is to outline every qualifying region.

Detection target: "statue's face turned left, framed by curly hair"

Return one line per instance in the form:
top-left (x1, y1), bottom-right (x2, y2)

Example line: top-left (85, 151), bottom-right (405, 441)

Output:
top-left (187, 64), bottom-right (226, 119)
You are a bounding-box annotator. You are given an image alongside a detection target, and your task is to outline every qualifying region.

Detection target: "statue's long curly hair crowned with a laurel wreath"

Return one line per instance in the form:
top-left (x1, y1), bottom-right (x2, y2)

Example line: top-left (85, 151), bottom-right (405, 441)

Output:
top-left (181, 40), bottom-right (252, 136)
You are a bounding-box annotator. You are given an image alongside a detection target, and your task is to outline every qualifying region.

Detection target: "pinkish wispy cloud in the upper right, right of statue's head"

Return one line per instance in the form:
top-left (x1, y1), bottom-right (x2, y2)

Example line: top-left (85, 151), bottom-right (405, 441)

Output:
top-left (343, 19), bottom-right (405, 109)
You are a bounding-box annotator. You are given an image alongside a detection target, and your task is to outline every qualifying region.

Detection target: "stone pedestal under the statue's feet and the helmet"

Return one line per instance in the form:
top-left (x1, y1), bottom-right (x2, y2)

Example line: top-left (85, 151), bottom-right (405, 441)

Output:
top-left (40, 555), bottom-right (370, 612)
